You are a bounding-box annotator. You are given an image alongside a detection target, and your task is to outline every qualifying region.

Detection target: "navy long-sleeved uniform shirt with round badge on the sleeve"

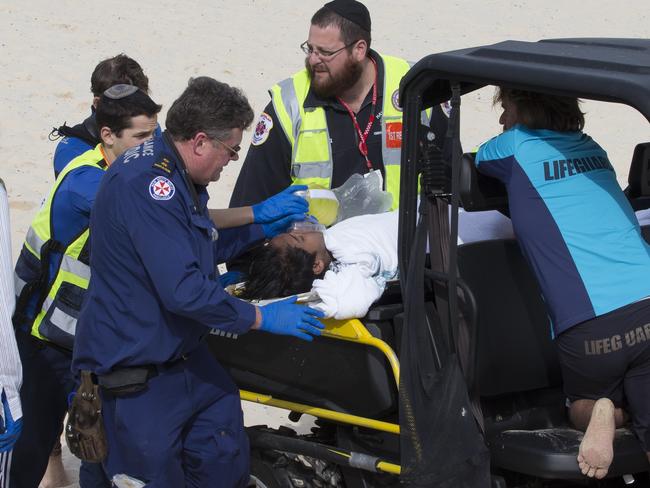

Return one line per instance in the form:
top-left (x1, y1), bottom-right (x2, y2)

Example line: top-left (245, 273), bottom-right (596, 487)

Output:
top-left (72, 133), bottom-right (264, 374)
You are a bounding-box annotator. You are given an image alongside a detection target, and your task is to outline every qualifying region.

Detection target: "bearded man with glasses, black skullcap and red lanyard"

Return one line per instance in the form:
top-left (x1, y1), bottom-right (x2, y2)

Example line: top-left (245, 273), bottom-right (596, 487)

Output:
top-left (230, 0), bottom-right (447, 208)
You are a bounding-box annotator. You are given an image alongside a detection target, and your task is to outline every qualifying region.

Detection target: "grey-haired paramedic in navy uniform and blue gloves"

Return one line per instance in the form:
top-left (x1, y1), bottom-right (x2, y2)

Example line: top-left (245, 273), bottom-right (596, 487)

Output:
top-left (72, 77), bottom-right (322, 488)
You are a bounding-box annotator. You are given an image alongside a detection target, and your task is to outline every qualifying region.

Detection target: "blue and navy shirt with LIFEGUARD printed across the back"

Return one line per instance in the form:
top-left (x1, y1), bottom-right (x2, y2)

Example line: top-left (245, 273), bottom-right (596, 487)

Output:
top-left (476, 125), bottom-right (650, 336)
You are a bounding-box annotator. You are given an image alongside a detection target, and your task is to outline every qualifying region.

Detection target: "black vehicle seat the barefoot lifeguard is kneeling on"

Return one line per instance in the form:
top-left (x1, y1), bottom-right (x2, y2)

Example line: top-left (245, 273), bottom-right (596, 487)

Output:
top-left (458, 229), bottom-right (648, 479)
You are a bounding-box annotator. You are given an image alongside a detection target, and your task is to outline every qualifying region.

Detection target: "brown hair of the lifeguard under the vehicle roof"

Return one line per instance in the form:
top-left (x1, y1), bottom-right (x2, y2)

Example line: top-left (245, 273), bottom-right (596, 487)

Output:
top-left (494, 87), bottom-right (585, 132)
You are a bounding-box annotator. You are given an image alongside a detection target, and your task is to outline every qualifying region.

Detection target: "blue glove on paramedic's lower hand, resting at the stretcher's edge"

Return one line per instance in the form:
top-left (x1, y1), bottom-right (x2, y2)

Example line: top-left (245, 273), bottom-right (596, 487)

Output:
top-left (260, 296), bottom-right (324, 341)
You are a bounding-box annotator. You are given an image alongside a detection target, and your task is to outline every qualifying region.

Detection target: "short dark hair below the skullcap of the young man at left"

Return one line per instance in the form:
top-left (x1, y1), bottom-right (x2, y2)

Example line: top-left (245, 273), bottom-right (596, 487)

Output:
top-left (95, 90), bottom-right (162, 137)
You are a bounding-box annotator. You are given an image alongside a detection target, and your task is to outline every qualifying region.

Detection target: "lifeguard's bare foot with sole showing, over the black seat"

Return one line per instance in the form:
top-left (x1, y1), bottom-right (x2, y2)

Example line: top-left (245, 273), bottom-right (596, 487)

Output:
top-left (578, 398), bottom-right (616, 479)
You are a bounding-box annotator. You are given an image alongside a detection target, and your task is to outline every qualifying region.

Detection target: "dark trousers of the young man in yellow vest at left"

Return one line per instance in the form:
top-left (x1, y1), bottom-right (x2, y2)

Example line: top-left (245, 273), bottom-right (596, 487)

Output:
top-left (10, 331), bottom-right (111, 488)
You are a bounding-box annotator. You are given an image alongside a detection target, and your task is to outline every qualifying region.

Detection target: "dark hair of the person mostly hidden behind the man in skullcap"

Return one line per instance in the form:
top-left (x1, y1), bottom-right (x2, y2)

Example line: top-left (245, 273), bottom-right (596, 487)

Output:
top-left (90, 53), bottom-right (149, 97)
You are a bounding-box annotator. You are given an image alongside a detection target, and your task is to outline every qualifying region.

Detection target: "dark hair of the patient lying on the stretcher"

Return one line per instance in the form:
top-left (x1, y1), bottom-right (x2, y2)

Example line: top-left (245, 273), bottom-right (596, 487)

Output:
top-left (240, 243), bottom-right (325, 300)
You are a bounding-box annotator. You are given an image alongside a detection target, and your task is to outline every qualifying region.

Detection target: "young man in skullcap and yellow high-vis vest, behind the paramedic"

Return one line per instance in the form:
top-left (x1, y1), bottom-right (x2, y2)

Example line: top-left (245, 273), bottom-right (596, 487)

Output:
top-left (11, 85), bottom-right (161, 488)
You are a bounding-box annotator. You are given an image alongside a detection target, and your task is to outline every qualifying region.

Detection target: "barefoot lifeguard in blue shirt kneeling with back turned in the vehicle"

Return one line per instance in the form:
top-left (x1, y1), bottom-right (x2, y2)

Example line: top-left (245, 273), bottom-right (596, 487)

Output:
top-left (476, 89), bottom-right (650, 478)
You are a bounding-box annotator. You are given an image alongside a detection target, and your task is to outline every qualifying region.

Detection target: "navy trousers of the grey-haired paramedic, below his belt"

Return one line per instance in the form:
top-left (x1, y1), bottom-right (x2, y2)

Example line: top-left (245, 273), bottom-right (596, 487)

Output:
top-left (102, 346), bottom-right (249, 488)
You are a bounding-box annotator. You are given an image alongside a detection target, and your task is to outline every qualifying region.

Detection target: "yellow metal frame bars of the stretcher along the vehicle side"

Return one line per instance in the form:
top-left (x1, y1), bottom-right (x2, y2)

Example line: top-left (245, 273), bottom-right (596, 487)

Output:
top-left (239, 319), bottom-right (401, 475)
